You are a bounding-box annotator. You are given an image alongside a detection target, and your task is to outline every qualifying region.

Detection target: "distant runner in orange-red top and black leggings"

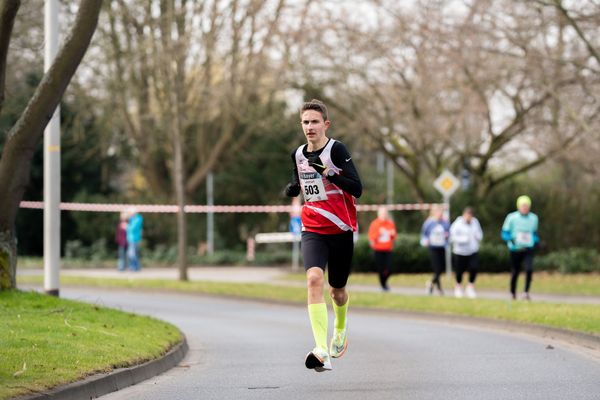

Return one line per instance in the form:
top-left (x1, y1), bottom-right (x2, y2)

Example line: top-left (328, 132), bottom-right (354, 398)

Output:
top-left (369, 207), bottom-right (397, 291)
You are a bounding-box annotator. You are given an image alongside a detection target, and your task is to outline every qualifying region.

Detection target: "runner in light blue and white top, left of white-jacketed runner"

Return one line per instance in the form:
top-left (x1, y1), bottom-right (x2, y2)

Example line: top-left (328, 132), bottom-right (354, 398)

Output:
top-left (421, 204), bottom-right (450, 295)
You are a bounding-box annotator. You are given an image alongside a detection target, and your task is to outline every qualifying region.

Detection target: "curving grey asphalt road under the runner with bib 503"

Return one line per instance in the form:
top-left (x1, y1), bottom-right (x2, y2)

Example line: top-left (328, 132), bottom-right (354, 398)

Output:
top-left (61, 288), bottom-right (600, 400)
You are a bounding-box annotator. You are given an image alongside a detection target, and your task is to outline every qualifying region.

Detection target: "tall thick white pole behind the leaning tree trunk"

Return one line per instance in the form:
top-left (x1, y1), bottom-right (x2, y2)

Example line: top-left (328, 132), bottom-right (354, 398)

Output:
top-left (44, 0), bottom-right (60, 296)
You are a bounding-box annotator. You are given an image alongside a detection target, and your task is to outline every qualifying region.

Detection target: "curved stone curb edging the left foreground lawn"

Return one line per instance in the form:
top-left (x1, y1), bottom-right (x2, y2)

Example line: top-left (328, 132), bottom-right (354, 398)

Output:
top-left (15, 336), bottom-right (189, 400)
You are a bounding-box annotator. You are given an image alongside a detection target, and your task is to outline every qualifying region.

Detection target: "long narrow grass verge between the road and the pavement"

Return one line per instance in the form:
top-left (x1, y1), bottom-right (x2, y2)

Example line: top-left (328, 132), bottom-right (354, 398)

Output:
top-left (18, 276), bottom-right (600, 335)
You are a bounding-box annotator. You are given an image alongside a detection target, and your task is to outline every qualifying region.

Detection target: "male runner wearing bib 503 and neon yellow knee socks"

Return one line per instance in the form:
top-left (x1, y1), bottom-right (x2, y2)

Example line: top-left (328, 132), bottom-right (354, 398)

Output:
top-left (286, 100), bottom-right (362, 372)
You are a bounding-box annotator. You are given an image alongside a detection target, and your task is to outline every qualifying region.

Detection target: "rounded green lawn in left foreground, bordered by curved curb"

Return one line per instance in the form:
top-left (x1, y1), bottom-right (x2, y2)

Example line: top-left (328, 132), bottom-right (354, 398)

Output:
top-left (0, 291), bottom-right (182, 399)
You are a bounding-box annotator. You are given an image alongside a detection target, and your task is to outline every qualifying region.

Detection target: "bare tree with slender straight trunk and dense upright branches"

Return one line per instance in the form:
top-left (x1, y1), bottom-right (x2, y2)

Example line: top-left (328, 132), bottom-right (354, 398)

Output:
top-left (91, 0), bottom-right (290, 280)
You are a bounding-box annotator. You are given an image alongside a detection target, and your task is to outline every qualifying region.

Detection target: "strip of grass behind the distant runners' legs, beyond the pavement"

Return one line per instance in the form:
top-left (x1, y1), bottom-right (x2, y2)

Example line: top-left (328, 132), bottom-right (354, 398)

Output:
top-left (285, 272), bottom-right (600, 296)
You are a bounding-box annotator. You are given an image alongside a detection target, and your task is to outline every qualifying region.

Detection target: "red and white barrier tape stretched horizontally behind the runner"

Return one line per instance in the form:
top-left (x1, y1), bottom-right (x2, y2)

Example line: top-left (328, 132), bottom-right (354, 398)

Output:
top-left (21, 201), bottom-right (434, 213)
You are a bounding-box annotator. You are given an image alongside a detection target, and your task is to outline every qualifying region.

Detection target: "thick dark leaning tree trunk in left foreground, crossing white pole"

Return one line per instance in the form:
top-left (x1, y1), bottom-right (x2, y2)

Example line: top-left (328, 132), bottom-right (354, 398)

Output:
top-left (0, 0), bottom-right (102, 289)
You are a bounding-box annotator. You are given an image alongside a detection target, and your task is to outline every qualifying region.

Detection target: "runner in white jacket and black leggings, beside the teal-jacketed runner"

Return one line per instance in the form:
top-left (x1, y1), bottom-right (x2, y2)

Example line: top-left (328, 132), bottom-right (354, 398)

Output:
top-left (450, 207), bottom-right (483, 299)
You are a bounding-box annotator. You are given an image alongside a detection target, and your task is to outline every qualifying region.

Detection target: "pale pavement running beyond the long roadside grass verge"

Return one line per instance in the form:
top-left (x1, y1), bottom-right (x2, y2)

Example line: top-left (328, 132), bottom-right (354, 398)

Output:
top-left (17, 267), bottom-right (600, 305)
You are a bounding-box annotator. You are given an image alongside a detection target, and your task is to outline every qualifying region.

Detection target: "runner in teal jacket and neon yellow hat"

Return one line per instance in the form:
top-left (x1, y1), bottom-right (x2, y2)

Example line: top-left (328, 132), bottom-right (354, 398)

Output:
top-left (502, 196), bottom-right (540, 300)
